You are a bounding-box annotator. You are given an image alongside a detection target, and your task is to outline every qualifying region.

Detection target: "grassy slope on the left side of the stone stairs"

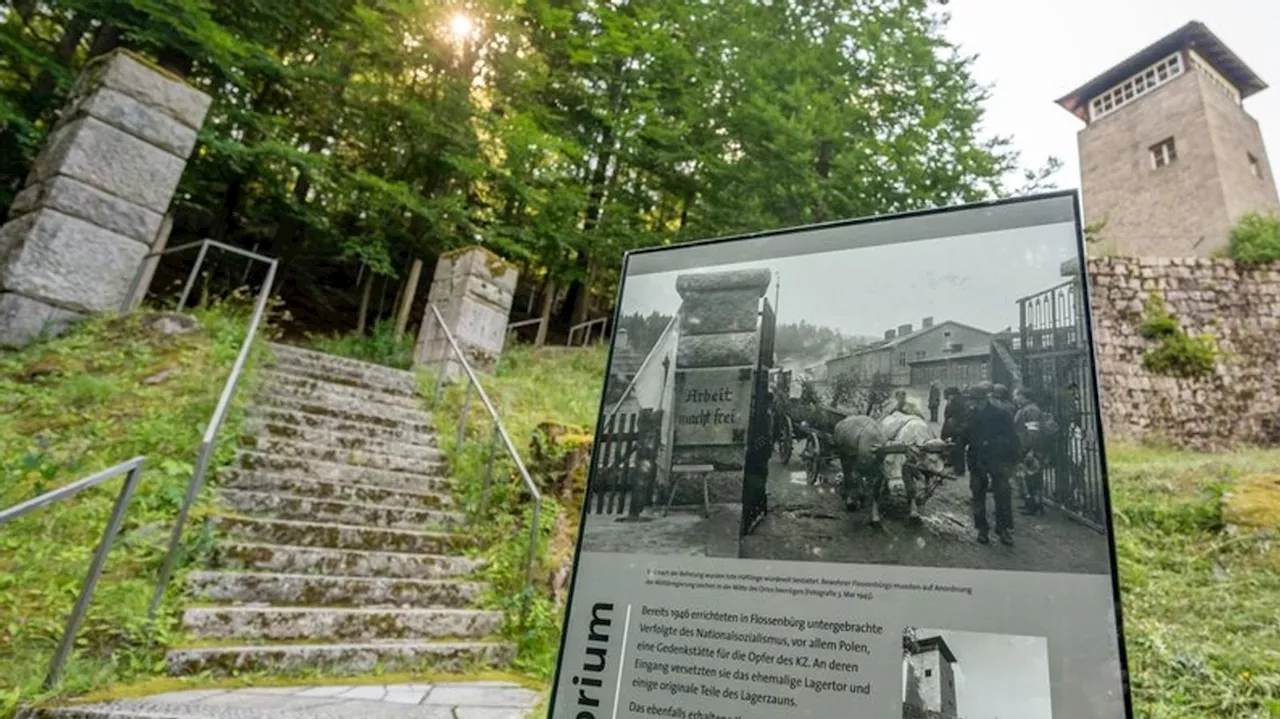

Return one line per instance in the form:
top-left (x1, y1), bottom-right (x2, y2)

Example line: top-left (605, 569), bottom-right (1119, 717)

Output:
top-left (0, 307), bottom-right (262, 716)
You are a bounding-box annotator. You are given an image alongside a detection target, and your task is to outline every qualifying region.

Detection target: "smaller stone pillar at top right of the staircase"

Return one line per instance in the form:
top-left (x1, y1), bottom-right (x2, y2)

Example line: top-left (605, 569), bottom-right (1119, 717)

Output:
top-left (413, 247), bottom-right (518, 375)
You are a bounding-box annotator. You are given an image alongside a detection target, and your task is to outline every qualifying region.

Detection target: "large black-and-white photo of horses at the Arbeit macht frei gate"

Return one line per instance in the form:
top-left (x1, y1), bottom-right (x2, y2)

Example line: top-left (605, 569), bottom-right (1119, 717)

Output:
top-left (582, 194), bottom-right (1110, 573)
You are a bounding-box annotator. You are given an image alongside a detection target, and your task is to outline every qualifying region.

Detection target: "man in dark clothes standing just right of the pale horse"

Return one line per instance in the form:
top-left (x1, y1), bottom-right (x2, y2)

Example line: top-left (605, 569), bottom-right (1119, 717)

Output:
top-left (968, 383), bottom-right (1018, 545)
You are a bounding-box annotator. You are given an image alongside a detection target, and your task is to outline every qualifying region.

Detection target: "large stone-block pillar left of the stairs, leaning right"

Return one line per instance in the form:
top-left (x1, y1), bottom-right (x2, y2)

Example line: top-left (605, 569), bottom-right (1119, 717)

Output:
top-left (0, 50), bottom-right (211, 347)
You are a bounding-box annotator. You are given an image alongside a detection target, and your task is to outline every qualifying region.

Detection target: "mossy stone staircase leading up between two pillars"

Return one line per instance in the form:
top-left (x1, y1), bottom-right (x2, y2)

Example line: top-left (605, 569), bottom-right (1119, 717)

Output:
top-left (168, 344), bottom-right (515, 676)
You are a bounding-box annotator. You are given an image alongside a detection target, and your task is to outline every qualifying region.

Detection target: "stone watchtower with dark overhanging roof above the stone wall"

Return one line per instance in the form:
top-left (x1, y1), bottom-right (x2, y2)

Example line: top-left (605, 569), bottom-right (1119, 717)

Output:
top-left (1057, 22), bottom-right (1280, 257)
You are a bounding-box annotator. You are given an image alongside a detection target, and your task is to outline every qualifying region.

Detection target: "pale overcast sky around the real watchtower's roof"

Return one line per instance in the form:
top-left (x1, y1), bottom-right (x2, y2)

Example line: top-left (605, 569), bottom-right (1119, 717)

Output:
top-left (947, 0), bottom-right (1280, 190)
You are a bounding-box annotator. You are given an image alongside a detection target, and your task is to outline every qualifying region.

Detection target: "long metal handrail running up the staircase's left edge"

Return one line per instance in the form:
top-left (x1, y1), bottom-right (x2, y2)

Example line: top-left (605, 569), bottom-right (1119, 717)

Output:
top-left (147, 255), bottom-right (280, 622)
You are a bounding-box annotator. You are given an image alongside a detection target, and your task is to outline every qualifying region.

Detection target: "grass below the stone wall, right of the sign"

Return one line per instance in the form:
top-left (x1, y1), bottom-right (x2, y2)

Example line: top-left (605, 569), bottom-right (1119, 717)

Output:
top-left (1108, 446), bottom-right (1280, 719)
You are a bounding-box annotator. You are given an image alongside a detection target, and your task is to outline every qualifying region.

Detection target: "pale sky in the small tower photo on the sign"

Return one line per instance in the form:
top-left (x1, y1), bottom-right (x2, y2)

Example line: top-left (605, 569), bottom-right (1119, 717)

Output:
top-left (919, 629), bottom-right (1053, 719)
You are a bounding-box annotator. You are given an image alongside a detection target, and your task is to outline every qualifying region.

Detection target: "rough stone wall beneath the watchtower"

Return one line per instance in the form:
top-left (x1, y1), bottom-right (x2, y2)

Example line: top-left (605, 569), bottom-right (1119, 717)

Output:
top-left (1089, 257), bottom-right (1280, 449)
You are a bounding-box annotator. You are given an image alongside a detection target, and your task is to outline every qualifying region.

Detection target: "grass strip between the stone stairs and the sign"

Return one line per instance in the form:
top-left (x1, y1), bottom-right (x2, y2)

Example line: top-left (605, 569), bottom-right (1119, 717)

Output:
top-left (422, 345), bottom-right (607, 679)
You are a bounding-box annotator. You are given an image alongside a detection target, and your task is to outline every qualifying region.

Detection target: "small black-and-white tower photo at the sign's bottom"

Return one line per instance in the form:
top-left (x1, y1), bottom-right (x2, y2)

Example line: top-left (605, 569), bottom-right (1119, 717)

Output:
top-left (902, 627), bottom-right (1053, 719)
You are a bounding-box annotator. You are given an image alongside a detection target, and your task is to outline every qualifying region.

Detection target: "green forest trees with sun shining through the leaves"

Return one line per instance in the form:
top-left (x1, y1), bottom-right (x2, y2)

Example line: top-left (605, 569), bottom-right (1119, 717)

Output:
top-left (0, 0), bottom-right (1057, 330)
